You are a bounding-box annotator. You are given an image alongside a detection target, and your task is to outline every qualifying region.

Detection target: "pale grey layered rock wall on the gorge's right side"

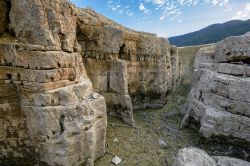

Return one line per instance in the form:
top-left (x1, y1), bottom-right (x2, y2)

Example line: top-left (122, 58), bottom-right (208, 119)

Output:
top-left (183, 33), bottom-right (250, 141)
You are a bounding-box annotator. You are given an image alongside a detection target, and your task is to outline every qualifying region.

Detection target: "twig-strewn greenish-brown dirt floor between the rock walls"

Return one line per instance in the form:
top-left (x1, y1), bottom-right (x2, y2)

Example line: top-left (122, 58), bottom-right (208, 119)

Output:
top-left (95, 85), bottom-right (200, 166)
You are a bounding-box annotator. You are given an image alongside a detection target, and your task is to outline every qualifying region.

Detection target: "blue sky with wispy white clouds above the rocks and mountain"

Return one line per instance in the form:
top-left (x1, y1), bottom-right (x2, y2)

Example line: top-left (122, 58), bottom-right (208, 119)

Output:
top-left (70, 0), bottom-right (250, 37)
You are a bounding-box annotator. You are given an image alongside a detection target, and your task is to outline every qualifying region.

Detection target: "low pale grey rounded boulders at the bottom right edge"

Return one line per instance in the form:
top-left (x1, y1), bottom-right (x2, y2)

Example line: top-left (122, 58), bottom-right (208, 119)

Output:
top-left (174, 147), bottom-right (250, 166)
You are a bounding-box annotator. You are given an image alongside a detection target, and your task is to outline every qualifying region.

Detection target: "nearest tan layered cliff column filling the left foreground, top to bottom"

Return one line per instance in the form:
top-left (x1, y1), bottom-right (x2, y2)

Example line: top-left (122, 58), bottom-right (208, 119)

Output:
top-left (0, 0), bottom-right (107, 166)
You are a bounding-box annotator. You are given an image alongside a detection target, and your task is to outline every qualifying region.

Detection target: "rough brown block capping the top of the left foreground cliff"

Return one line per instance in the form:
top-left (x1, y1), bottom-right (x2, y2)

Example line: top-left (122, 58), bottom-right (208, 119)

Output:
top-left (10, 0), bottom-right (77, 52)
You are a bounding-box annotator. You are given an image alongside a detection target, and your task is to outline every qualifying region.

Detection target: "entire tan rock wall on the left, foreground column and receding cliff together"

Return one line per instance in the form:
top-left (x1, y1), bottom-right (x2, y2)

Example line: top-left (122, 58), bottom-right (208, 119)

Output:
top-left (0, 0), bottom-right (180, 166)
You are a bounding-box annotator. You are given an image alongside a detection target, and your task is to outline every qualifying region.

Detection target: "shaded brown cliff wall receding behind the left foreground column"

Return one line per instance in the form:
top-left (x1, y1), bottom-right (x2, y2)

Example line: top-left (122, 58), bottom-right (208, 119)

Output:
top-left (77, 9), bottom-right (179, 124)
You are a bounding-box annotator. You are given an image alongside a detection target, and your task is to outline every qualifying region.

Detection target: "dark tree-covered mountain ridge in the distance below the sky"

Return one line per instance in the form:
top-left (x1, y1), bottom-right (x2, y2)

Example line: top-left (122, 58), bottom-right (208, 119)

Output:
top-left (169, 19), bottom-right (250, 47)
